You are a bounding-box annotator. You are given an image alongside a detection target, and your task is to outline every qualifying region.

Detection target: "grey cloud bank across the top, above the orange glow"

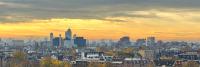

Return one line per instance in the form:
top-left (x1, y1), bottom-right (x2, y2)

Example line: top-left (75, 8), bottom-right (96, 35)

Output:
top-left (0, 0), bottom-right (200, 22)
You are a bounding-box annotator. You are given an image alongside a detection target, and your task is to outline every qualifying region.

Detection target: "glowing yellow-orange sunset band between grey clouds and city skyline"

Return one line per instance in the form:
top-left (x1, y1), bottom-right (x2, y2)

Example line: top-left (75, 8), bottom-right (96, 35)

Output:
top-left (0, 10), bottom-right (200, 40)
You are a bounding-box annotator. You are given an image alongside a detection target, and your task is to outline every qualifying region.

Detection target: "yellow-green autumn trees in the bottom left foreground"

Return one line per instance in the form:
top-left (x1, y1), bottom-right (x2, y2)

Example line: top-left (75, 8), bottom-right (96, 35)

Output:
top-left (0, 51), bottom-right (72, 67)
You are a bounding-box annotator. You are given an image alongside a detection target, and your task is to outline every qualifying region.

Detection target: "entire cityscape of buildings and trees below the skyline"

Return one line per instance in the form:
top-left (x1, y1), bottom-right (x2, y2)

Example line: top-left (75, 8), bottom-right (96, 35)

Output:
top-left (0, 28), bottom-right (200, 67)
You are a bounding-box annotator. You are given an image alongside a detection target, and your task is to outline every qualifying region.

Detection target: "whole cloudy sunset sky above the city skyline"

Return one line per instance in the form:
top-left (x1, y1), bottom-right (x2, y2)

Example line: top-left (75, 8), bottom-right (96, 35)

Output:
top-left (0, 0), bottom-right (200, 41)
